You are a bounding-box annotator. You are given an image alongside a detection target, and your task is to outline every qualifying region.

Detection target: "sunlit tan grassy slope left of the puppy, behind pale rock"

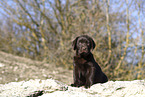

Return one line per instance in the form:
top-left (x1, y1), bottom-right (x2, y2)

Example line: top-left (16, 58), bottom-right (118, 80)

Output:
top-left (0, 51), bottom-right (73, 85)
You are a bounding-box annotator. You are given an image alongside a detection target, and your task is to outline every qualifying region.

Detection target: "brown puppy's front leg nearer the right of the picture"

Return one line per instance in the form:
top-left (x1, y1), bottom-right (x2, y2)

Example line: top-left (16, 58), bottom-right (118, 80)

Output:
top-left (85, 67), bottom-right (95, 88)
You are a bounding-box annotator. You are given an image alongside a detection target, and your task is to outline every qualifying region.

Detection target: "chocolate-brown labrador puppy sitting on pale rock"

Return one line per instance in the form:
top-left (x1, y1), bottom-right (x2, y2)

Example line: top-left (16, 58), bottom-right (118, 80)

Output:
top-left (71, 35), bottom-right (108, 88)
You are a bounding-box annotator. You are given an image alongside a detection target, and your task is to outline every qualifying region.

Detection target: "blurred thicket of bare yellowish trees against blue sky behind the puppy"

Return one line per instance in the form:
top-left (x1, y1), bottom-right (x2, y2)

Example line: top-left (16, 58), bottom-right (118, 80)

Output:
top-left (0, 0), bottom-right (145, 80)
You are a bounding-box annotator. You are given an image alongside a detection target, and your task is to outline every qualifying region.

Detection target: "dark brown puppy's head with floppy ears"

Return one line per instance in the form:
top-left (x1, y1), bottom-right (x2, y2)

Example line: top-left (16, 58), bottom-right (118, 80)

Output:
top-left (73, 35), bottom-right (95, 56)
